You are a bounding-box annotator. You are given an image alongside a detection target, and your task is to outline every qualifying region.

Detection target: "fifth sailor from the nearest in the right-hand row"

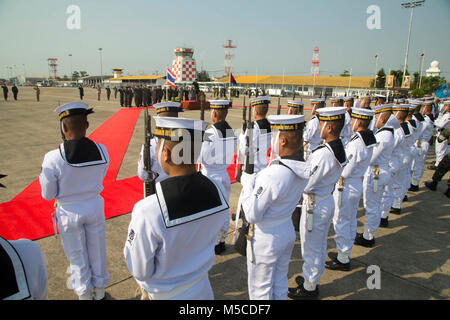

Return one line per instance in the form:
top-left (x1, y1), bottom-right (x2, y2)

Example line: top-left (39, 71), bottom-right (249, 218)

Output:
top-left (390, 104), bottom-right (415, 214)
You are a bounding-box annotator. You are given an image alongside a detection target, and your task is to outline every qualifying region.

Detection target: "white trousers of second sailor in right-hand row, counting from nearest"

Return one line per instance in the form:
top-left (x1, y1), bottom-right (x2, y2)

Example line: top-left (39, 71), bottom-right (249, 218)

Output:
top-left (300, 194), bottom-right (334, 284)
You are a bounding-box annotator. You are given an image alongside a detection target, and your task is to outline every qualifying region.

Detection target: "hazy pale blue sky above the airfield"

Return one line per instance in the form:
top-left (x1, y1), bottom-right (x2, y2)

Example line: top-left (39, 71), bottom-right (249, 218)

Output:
top-left (0, 0), bottom-right (450, 79)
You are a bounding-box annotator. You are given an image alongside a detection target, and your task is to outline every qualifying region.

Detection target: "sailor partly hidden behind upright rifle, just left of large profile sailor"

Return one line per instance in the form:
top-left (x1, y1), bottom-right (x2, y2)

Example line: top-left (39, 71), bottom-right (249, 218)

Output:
top-left (239, 96), bottom-right (272, 173)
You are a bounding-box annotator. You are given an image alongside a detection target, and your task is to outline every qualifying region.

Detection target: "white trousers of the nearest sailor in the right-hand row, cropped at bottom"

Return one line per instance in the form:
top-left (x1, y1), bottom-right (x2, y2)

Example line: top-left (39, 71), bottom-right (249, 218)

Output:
top-left (247, 232), bottom-right (295, 300)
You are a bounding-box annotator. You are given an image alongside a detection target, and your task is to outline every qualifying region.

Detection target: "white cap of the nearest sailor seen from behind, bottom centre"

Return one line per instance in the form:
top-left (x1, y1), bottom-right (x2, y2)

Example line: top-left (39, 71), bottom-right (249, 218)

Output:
top-left (154, 116), bottom-right (208, 141)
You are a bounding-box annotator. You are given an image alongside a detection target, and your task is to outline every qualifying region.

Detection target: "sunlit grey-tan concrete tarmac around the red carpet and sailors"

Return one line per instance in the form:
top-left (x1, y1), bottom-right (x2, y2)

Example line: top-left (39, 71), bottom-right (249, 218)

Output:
top-left (0, 87), bottom-right (450, 300)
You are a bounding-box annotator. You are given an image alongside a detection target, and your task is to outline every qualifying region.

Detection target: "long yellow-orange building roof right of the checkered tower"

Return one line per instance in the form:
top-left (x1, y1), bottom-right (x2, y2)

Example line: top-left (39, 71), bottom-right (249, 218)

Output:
top-left (216, 76), bottom-right (373, 88)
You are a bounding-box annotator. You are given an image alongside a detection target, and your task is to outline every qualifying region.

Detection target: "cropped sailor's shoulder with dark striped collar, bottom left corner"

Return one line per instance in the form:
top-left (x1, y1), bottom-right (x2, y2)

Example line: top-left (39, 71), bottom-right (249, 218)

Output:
top-left (0, 237), bottom-right (48, 300)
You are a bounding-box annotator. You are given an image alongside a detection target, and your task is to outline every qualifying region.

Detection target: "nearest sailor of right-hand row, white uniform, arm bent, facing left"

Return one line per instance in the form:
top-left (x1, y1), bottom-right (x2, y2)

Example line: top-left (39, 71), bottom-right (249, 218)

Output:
top-left (241, 115), bottom-right (310, 300)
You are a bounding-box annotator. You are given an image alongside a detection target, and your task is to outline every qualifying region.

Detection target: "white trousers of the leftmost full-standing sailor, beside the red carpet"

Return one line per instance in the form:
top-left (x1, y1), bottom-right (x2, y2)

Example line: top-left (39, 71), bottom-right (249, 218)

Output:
top-left (56, 196), bottom-right (109, 296)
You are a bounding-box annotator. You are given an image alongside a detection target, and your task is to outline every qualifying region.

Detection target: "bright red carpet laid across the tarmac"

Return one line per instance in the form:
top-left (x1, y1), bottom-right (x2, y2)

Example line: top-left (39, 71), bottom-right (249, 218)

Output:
top-left (0, 108), bottom-right (240, 240)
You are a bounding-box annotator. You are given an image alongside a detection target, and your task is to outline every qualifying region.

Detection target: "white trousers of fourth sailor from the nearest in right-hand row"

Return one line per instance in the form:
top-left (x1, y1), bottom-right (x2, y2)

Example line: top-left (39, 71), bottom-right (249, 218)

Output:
top-left (363, 167), bottom-right (391, 235)
